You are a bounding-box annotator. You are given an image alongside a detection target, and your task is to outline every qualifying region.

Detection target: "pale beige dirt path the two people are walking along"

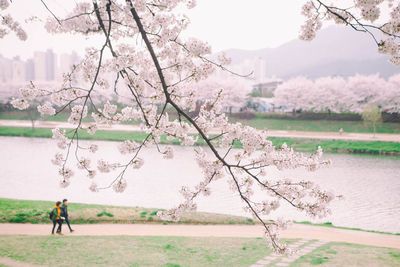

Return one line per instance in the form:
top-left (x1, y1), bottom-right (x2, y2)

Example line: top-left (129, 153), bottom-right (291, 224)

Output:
top-left (0, 224), bottom-right (400, 249)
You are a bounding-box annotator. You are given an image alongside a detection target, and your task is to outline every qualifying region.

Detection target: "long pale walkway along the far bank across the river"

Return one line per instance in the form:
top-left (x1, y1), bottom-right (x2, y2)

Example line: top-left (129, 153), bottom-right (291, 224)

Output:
top-left (0, 120), bottom-right (400, 142)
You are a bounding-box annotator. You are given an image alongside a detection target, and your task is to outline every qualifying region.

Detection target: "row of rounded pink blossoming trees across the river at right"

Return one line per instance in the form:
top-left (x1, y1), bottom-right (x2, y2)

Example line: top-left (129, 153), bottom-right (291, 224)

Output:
top-left (274, 74), bottom-right (400, 113)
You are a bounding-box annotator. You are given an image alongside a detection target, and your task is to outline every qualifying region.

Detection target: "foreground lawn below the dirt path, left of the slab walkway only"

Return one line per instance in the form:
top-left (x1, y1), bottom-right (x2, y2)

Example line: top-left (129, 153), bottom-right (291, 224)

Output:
top-left (0, 236), bottom-right (271, 267)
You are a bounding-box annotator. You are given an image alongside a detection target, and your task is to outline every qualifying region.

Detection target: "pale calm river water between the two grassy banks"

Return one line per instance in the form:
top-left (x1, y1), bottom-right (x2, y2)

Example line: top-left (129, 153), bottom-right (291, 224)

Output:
top-left (0, 137), bottom-right (400, 233)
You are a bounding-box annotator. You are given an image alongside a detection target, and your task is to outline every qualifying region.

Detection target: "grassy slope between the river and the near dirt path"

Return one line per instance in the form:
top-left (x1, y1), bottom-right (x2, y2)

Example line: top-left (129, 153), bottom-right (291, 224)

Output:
top-left (0, 198), bottom-right (253, 224)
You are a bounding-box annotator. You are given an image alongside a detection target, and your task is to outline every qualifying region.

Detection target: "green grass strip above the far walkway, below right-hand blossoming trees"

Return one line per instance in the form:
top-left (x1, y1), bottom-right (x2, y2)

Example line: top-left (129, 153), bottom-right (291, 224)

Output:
top-left (232, 117), bottom-right (400, 134)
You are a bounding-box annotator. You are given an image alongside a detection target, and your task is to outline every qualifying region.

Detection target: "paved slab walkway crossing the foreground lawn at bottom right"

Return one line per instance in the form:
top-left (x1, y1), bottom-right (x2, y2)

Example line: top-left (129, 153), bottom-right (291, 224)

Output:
top-left (250, 239), bottom-right (329, 267)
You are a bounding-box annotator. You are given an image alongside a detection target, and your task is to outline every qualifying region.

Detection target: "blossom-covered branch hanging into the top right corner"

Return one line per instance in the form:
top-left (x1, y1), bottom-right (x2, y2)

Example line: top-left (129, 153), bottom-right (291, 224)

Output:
top-left (300, 0), bottom-right (400, 65)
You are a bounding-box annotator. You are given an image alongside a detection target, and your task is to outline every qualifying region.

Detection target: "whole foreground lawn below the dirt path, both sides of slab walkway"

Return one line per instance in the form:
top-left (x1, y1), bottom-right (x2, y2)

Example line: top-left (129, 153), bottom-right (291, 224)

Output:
top-left (0, 236), bottom-right (400, 267)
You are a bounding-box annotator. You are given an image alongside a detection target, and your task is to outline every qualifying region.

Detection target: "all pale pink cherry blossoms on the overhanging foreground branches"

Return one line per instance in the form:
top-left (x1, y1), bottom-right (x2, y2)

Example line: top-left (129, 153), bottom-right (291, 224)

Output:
top-left (0, 0), bottom-right (400, 252)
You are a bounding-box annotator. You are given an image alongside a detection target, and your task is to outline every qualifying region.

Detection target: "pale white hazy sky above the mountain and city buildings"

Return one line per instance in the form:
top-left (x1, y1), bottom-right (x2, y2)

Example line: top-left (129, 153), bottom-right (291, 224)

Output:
top-left (0, 0), bottom-right (304, 58)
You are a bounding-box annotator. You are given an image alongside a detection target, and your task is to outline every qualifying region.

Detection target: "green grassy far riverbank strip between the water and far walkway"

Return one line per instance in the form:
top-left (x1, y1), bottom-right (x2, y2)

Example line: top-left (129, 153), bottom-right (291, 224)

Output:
top-left (0, 126), bottom-right (400, 155)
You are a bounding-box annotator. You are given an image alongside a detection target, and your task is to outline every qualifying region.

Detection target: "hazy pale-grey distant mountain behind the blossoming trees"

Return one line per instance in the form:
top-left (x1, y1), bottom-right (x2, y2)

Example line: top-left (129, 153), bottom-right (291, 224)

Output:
top-left (225, 26), bottom-right (400, 79)
